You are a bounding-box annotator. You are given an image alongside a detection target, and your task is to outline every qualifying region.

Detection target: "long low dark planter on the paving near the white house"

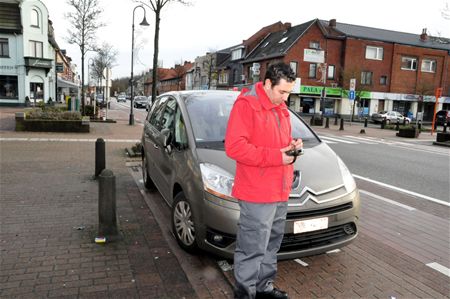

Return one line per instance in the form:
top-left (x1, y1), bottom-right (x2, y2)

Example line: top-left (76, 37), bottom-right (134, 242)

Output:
top-left (16, 112), bottom-right (89, 133)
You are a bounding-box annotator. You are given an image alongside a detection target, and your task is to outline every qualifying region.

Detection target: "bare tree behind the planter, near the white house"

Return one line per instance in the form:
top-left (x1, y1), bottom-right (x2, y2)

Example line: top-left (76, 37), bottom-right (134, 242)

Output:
top-left (65, 0), bottom-right (104, 113)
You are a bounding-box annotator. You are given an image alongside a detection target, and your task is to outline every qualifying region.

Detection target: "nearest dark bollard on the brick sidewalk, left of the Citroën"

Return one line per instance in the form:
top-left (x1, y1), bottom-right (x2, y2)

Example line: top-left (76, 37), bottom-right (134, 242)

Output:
top-left (98, 169), bottom-right (118, 241)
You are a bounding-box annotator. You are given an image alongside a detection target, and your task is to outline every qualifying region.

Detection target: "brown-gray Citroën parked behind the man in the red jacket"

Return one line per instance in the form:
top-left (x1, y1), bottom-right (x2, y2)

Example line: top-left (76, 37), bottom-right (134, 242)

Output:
top-left (142, 90), bottom-right (360, 259)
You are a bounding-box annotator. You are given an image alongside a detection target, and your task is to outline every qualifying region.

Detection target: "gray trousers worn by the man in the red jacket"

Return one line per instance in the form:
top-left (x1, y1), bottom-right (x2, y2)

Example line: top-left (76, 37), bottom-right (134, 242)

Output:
top-left (234, 200), bottom-right (287, 299)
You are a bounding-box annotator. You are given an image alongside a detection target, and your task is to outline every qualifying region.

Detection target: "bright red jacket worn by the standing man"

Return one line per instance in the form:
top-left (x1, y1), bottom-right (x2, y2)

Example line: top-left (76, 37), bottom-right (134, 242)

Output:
top-left (225, 82), bottom-right (293, 203)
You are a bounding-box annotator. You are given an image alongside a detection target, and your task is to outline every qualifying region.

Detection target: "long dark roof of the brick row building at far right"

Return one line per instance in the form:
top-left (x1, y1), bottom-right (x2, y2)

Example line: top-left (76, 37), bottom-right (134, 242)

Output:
top-left (320, 20), bottom-right (450, 50)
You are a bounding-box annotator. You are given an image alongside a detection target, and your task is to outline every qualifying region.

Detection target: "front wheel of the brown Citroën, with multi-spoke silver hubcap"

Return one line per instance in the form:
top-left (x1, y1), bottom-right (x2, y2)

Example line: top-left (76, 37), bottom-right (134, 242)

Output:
top-left (172, 192), bottom-right (198, 253)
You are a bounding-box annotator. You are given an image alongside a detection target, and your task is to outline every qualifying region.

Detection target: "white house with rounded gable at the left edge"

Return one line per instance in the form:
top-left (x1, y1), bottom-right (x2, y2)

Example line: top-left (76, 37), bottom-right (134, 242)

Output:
top-left (0, 0), bottom-right (57, 105)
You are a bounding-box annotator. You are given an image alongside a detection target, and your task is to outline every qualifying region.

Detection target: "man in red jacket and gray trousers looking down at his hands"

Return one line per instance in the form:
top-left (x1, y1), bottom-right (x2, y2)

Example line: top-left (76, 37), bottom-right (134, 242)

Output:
top-left (225, 63), bottom-right (303, 299)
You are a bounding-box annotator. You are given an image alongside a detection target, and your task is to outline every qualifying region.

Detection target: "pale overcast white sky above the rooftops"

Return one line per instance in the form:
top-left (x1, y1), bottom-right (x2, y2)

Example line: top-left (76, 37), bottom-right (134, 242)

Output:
top-left (41, 0), bottom-right (450, 79)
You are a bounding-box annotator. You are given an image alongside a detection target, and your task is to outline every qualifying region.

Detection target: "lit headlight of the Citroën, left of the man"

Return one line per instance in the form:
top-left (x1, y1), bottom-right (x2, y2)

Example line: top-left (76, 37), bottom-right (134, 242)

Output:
top-left (200, 163), bottom-right (234, 200)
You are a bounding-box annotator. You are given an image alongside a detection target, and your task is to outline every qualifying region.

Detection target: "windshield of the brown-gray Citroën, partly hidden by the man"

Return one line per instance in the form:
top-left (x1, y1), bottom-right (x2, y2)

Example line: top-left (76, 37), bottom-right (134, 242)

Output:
top-left (185, 92), bottom-right (319, 149)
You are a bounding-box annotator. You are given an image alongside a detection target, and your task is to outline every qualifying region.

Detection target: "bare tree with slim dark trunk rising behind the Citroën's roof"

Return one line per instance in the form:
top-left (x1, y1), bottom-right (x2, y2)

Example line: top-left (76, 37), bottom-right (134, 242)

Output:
top-left (135, 0), bottom-right (190, 99)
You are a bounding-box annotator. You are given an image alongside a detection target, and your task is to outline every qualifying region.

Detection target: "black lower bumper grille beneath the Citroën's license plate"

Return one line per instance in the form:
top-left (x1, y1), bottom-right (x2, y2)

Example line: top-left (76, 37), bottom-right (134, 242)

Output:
top-left (280, 223), bottom-right (356, 252)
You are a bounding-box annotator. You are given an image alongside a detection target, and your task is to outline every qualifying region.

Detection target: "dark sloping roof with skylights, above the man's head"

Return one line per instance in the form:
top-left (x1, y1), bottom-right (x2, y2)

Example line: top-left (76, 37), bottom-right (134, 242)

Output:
top-left (243, 20), bottom-right (316, 62)
